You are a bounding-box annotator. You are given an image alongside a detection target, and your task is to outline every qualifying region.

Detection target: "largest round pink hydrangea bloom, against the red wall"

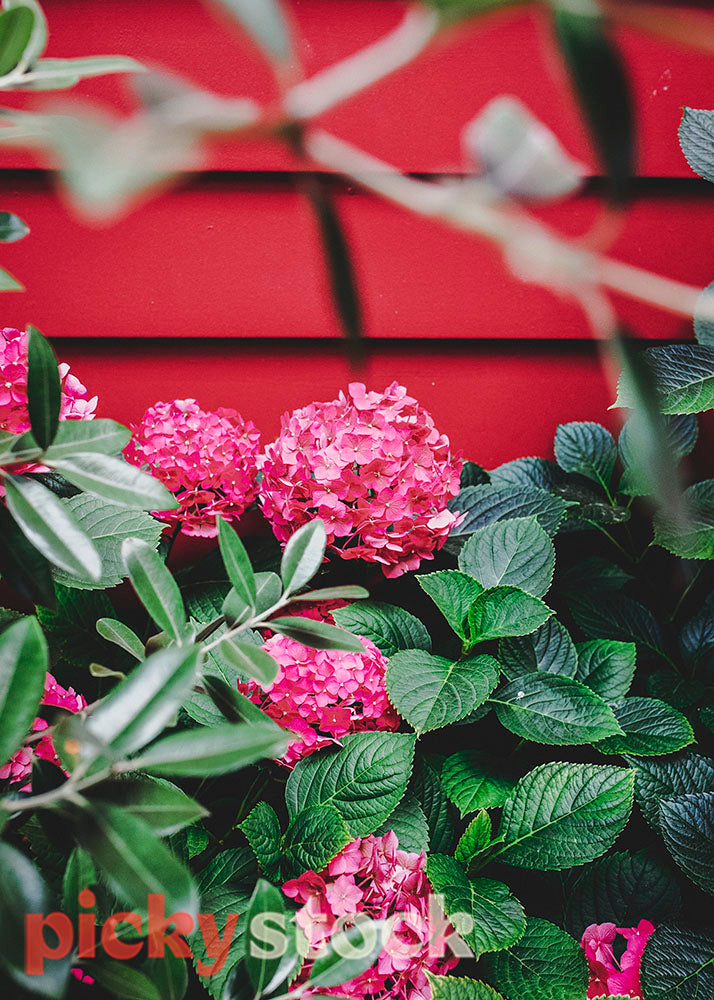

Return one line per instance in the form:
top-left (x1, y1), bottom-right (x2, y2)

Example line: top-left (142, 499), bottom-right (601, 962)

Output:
top-left (260, 382), bottom-right (461, 577)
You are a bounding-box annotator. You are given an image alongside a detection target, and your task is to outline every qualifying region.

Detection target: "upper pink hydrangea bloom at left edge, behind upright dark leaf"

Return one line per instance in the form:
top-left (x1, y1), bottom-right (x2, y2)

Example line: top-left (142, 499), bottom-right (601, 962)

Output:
top-left (0, 327), bottom-right (97, 434)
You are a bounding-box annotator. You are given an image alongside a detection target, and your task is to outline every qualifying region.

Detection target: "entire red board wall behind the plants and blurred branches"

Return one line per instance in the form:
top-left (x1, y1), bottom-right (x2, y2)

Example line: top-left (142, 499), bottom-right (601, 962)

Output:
top-left (0, 0), bottom-right (714, 465)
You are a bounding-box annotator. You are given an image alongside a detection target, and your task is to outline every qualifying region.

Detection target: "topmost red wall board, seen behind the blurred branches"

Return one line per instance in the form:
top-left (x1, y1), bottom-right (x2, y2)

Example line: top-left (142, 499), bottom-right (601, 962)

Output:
top-left (0, 0), bottom-right (714, 177)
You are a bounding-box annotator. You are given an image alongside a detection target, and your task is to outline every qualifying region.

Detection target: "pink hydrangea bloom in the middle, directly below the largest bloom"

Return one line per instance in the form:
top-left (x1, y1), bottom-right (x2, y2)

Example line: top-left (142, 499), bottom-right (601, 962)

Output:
top-left (238, 601), bottom-right (399, 767)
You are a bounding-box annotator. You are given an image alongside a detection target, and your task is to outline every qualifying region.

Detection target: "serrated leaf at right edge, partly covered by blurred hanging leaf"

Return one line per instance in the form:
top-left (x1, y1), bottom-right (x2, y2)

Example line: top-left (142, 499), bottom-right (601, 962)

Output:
top-left (615, 344), bottom-right (714, 414)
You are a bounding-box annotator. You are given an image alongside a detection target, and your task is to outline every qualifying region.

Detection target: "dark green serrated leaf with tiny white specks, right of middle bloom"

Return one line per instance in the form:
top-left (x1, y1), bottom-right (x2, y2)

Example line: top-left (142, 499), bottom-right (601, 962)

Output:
top-left (490, 673), bottom-right (622, 746)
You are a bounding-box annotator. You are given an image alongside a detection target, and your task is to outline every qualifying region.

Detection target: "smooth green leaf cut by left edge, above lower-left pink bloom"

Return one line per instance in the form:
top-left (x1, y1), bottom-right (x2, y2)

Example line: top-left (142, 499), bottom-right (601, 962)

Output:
top-left (0, 618), bottom-right (48, 764)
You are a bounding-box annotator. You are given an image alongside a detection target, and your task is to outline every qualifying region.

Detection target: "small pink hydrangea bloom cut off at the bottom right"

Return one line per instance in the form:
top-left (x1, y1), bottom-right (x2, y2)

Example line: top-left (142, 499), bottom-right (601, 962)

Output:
top-left (580, 920), bottom-right (654, 1000)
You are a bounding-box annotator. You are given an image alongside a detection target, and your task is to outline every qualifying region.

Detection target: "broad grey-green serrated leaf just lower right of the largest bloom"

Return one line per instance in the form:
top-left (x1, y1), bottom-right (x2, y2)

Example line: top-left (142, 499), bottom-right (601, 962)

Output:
top-left (459, 517), bottom-right (555, 597)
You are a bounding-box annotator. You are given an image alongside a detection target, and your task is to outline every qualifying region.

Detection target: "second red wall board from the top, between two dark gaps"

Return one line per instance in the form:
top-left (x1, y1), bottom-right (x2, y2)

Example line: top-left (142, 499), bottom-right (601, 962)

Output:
top-left (0, 173), bottom-right (714, 339)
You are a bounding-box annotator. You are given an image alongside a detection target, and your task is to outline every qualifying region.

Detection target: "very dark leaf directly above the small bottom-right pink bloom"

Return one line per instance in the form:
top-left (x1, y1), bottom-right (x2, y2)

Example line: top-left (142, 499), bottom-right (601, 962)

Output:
top-left (566, 851), bottom-right (682, 937)
